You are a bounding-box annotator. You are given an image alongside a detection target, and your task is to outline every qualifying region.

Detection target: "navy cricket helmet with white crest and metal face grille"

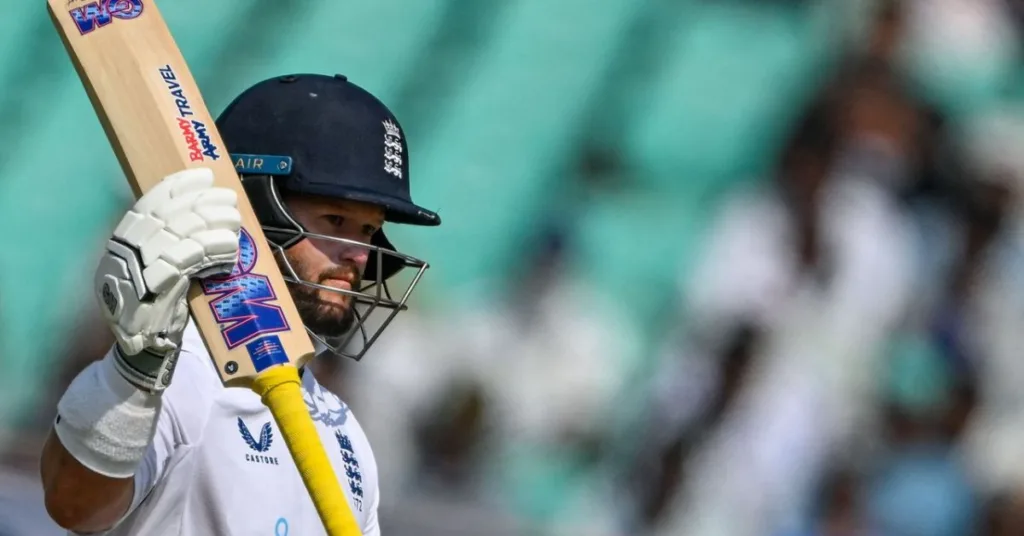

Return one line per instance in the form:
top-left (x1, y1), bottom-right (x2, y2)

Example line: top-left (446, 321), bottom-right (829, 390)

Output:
top-left (217, 74), bottom-right (440, 361)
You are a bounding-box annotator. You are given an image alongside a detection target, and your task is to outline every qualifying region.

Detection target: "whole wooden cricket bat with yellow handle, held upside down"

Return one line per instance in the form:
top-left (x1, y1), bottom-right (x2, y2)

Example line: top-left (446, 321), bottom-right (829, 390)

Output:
top-left (47, 0), bottom-right (361, 536)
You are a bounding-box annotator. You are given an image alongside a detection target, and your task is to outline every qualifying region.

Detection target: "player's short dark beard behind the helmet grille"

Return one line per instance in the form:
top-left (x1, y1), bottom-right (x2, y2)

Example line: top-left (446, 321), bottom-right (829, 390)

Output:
top-left (284, 252), bottom-right (361, 338)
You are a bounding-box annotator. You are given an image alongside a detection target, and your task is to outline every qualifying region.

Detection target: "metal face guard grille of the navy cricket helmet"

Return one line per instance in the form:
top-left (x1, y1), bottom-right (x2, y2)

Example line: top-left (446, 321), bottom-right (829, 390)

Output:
top-left (243, 175), bottom-right (429, 361)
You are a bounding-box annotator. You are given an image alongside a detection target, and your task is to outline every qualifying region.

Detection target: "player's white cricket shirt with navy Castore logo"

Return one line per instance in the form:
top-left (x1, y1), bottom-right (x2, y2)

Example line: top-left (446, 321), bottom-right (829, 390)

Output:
top-left (87, 322), bottom-right (380, 536)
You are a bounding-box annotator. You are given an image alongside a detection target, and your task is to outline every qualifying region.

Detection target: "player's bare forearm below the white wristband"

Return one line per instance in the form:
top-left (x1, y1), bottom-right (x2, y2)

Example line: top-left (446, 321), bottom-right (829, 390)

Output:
top-left (40, 431), bottom-right (135, 533)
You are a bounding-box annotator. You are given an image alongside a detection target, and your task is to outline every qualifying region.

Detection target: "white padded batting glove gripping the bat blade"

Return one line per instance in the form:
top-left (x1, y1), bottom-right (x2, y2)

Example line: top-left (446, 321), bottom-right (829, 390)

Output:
top-left (94, 168), bottom-right (242, 393)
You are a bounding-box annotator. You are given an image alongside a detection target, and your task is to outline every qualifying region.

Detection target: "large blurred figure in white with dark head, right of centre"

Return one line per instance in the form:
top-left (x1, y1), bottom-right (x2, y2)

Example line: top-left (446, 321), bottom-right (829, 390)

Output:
top-left (630, 11), bottom-right (925, 536)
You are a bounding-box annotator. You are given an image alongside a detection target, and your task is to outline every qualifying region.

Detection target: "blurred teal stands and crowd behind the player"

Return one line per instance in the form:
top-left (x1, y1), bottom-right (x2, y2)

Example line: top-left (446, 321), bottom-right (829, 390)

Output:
top-left (6, 0), bottom-right (1024, 536)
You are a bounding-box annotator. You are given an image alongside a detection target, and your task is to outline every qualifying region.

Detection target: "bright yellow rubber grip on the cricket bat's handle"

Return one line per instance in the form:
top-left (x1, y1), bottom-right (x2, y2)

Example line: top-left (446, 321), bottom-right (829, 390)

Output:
top-left (252, 365), bottom-right (362, 536)
